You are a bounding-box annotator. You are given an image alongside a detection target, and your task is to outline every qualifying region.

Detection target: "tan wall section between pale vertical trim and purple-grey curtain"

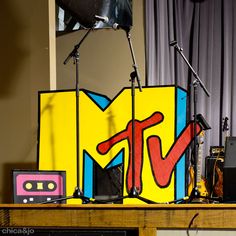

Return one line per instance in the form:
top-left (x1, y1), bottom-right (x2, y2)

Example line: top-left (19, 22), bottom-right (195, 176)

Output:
top-left (57, 0), bottom-right (145, 98)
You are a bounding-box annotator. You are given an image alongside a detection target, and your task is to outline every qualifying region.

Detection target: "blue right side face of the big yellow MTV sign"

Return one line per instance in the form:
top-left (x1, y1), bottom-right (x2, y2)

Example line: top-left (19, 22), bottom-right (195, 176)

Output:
top-left (175, 88), bottom-right (187, 199)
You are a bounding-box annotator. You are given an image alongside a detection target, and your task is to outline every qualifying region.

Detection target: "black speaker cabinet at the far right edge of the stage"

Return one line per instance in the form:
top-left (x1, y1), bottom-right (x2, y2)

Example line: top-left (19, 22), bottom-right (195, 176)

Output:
top-left (223, 137), bottom-right (236, 202)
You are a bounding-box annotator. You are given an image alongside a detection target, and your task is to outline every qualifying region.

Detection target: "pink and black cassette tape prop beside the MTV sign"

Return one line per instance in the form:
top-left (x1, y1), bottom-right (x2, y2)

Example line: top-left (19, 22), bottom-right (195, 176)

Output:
top-left (13, 170), bottom-right (66, 204)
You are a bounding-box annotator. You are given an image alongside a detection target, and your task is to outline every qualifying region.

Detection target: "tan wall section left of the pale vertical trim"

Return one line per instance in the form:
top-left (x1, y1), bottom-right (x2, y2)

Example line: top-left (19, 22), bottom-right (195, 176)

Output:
top-left (0, 0), bottom-right (49, 203)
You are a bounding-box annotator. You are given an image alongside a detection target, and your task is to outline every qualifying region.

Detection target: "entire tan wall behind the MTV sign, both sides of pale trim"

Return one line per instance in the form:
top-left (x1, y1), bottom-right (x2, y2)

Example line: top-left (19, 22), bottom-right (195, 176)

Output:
top-left (0, 0), bottom-right (145, 203)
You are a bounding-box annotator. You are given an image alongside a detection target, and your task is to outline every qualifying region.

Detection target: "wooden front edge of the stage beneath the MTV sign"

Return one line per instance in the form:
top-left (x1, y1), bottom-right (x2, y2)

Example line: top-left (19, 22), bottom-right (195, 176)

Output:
top-left (0, 204), bottom-right (236, 236)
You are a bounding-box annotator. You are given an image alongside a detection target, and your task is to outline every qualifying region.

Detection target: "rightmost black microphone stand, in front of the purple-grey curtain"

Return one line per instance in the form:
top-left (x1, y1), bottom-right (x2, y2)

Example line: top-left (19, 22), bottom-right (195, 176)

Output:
top-left (170, 41), bottom-right (214, 202)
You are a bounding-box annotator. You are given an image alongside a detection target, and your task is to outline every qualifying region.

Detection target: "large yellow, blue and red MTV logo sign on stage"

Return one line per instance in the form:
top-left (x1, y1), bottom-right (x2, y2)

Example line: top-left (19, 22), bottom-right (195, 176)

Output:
top-left (38, 86), bottom-right (191, 204)
